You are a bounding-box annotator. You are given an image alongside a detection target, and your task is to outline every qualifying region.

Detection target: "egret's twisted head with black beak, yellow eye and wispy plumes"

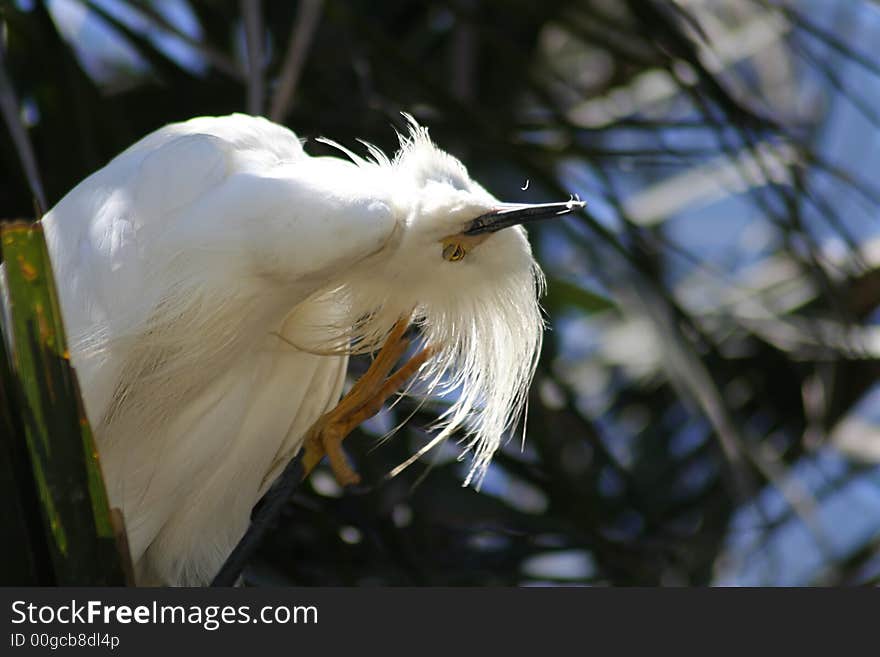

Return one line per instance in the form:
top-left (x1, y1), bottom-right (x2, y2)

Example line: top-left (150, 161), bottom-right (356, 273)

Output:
top-left (312, 120), bottom-right (583, 485)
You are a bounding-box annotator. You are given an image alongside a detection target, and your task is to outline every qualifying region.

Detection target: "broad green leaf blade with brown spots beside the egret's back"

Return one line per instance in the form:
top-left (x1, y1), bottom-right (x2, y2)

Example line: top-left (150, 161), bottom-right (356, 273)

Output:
top-left (2, 222), bottom-right (125, 585)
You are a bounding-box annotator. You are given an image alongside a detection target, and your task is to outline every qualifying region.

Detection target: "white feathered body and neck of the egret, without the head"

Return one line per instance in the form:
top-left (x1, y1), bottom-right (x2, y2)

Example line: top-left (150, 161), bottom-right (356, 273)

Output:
top-left (43, 115), bottom-right (395, 583)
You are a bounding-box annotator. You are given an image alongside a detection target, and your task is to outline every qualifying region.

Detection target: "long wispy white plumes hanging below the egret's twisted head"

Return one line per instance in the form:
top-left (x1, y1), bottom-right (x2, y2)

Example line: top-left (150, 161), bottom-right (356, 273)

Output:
top-left (312, 246), bottom-right (544, 487)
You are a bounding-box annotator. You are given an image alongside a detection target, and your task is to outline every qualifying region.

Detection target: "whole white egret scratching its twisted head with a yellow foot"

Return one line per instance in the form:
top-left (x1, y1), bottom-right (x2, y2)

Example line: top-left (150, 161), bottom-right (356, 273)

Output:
top-left (42, 115), bottom-right (581, 585)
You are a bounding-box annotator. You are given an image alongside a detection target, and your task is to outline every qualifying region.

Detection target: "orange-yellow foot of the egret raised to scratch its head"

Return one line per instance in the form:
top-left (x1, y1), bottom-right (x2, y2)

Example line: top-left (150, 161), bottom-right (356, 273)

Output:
top-left (303, 318), bottom-right (433, 486)
